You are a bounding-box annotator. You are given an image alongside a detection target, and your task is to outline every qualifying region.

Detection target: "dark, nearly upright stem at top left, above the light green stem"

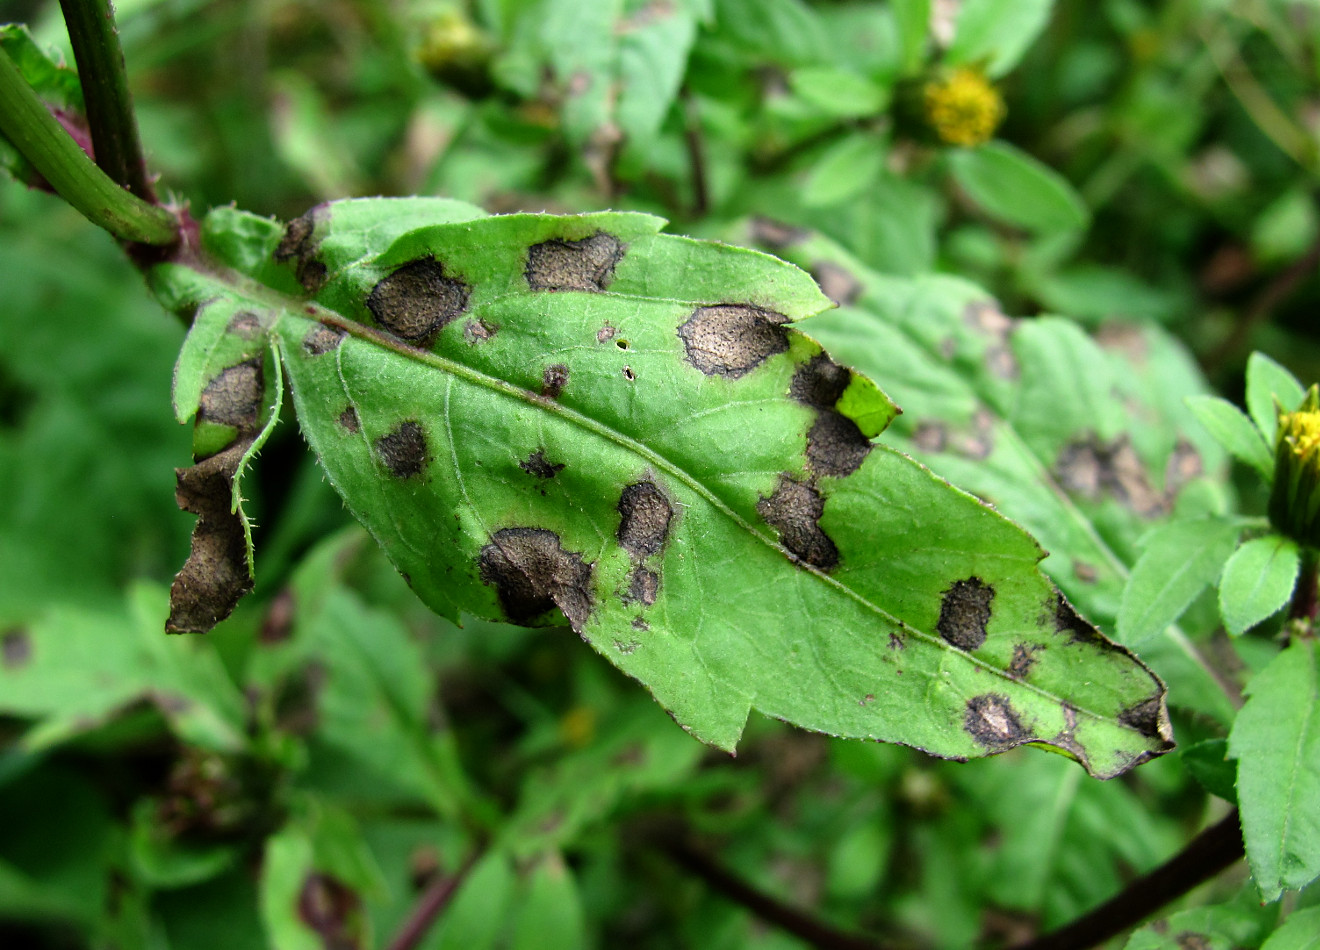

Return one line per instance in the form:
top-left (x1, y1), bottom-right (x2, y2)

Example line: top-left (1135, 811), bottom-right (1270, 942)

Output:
top-left (59, 0), bottom-right (156, 205)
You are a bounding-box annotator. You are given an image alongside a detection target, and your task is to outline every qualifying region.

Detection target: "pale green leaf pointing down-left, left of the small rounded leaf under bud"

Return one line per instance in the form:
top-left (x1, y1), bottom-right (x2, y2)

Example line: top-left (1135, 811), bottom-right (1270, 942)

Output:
top-left (1118, 517), bottom-right (1242, 645)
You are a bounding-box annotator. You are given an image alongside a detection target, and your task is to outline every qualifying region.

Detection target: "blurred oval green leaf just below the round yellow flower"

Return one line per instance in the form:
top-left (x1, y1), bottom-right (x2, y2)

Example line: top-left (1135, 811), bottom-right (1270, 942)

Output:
top-left (949, 141), bottom-right (1090, 234)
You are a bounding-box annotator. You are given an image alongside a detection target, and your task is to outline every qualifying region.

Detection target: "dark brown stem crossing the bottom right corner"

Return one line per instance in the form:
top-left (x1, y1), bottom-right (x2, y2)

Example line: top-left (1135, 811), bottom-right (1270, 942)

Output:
top-left (1012, 809), bottom-right (1243, 950)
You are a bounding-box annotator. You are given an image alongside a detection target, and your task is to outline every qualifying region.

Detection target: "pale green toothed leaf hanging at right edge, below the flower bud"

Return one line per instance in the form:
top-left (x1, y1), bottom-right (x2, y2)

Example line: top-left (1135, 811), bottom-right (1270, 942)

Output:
top-left (1229, 640), bottom-right (1320, 901)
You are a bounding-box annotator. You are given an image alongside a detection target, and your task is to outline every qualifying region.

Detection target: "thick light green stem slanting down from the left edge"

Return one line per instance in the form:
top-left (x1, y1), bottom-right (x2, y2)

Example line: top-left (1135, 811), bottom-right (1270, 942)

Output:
top-left (0, 51), bottom-right (178, 245)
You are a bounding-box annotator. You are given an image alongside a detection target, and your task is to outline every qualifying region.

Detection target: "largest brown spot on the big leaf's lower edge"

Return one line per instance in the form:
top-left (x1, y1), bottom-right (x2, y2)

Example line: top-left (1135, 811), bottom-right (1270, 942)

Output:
top-left (478, 528), bottom-right (591, 629)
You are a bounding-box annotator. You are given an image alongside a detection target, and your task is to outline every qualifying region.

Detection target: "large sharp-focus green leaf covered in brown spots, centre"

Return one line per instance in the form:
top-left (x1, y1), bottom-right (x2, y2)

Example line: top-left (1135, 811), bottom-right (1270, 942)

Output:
top-left (160, 201), bottom-right (1170, 777)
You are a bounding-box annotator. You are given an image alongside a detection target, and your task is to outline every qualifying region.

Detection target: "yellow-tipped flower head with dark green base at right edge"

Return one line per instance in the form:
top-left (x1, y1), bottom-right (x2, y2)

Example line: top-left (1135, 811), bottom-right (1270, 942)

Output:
top-left (1270, 385), bottom-right (1320, 548)
